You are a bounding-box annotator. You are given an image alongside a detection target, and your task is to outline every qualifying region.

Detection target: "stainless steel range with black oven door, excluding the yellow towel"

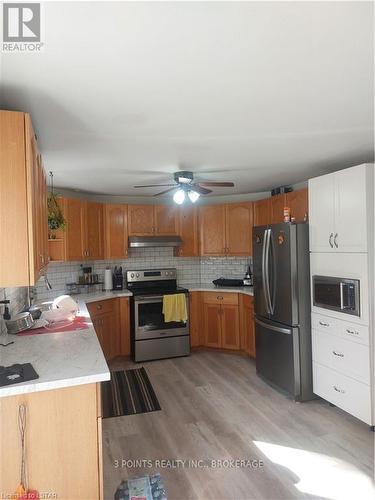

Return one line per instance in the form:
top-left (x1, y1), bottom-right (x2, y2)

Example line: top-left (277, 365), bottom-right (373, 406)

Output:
top-left (126, 268), bottom-right (190, 361)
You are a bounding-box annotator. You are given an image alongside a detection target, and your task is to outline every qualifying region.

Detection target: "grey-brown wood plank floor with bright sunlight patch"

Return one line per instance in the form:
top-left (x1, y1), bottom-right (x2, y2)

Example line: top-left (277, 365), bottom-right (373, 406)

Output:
top-left (103, 351), bottom-right (374, 500)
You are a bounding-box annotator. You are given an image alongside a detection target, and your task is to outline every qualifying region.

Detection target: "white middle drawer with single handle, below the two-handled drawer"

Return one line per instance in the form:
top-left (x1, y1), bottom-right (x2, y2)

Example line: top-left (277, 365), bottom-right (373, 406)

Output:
top-left (312, 330), bottom-right (370, 384)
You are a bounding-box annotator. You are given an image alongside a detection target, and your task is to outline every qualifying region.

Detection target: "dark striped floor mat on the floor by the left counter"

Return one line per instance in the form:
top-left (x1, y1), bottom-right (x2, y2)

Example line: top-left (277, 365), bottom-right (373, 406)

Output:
top-left (102, 367), bottom-right (161, 418)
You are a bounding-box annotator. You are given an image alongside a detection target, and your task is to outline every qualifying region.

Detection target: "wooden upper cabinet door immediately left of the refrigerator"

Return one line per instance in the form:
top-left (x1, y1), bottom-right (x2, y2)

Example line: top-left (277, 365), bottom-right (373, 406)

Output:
top-left (225, 202), bottom-right (253, 257)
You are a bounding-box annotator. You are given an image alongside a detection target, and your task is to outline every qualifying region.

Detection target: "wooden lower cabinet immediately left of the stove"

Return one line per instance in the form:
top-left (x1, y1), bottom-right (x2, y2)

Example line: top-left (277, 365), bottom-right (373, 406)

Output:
top-left (87, 297), bottom-right (130, 360)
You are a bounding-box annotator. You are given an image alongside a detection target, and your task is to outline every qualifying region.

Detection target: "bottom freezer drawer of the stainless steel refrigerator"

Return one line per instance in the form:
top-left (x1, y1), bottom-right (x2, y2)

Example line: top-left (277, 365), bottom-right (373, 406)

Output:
top-left (255, 318), bottom-right (301, 399)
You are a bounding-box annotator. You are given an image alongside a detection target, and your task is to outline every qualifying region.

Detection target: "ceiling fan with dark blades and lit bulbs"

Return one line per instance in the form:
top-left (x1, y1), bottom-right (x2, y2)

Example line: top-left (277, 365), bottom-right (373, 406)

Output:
top-left (134, 170), bottom-right (234, 205)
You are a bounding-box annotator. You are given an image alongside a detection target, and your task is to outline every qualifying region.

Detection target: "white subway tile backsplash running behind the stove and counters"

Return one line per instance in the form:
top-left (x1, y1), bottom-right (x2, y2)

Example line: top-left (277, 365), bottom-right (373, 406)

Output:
top-left (35, 248), bottom-right (251, 300)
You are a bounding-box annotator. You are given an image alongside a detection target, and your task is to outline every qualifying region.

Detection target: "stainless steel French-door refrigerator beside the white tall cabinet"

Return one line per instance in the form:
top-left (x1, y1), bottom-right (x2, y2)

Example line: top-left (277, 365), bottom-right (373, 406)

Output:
top-left (253, 223), bottom-right (314, 401)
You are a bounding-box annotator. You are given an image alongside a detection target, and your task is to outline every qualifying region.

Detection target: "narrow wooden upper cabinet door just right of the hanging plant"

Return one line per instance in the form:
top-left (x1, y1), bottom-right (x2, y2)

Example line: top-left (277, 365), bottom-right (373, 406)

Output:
top-left (65, 198), bottom-right (87, 261)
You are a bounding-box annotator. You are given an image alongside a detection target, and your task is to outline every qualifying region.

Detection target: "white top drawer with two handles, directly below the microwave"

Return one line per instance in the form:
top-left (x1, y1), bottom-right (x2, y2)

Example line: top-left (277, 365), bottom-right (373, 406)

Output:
top-left (311, 313), bottom-right (369, 345)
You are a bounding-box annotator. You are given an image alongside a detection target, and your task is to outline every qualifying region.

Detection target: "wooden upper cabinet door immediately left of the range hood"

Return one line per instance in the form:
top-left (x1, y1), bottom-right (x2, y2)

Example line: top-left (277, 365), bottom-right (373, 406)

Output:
top-left (104, 205), bottom-right (128, 260)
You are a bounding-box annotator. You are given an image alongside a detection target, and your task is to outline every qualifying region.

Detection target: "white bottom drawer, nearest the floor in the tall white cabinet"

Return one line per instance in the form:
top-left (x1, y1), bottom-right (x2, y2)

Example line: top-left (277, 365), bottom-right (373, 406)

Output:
top-left (313, 362), bottom-right (371, 424)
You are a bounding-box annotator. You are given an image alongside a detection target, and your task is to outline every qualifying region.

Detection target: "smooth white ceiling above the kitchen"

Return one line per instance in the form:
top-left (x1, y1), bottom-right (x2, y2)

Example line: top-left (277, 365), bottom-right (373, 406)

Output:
top-left (1, 1), bottom-right (374, 195)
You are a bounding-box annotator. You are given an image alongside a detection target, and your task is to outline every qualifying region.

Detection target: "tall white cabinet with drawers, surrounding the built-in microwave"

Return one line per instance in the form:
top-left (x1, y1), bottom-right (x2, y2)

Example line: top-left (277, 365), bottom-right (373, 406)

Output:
top-left (309, 164), bottom-right (375, 430)
